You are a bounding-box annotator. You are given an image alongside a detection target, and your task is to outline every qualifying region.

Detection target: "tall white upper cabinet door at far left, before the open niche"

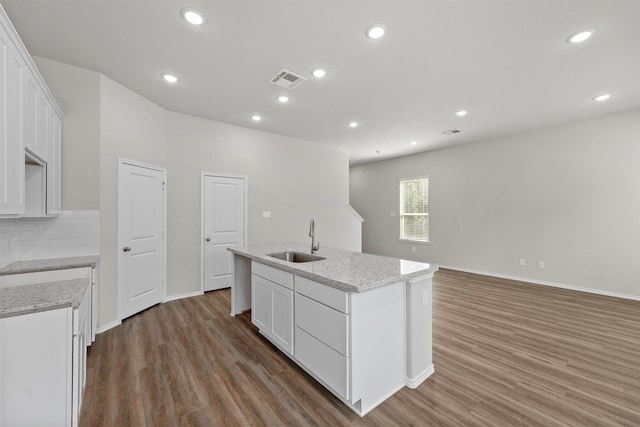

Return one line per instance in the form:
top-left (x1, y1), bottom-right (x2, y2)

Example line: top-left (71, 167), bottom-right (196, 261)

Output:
top-left (0, 25), bottom-right (26, 215)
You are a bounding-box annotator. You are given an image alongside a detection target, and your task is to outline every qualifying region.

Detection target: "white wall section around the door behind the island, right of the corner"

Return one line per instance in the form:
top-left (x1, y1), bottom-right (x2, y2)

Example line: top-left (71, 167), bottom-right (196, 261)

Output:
top-left (167, 113), bottom-right (361, 295)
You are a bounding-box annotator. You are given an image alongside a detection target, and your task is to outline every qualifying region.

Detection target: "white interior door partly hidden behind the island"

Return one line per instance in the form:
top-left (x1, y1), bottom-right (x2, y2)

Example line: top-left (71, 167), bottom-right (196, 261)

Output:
top-left (202, 175), bottom-right (246, 291)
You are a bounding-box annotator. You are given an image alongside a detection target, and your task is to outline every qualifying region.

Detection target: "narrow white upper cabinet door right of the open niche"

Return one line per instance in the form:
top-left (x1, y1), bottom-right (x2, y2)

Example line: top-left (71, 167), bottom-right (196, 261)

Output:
top-left (47, 108), bottom-right (62, 215)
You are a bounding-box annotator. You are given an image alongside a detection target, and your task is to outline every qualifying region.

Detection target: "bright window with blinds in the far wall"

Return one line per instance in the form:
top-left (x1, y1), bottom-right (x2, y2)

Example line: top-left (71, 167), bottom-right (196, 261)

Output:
top-left (400, 177), bottom-right (429, 242)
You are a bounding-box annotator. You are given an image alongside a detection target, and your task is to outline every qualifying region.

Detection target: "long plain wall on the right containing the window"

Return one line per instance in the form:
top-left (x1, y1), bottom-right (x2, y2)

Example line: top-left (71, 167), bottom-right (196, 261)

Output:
top-left (351, 110), bottom-right (640, 298)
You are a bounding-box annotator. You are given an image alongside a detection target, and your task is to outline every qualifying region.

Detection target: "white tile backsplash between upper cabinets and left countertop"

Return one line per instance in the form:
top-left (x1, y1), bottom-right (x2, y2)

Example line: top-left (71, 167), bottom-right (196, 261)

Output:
top-left (0, 210), bottom-right (100, 268)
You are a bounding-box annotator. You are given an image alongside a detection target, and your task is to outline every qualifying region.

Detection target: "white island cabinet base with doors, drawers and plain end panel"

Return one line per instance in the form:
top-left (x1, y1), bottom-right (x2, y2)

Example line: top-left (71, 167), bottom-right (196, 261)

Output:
top-left (251, 262), bottom-right (406, 415)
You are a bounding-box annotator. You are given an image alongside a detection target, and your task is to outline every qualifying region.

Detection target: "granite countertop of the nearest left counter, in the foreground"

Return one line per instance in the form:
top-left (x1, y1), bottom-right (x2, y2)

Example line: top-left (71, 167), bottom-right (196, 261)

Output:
top-left (0, 278), bottom-right (90, 318)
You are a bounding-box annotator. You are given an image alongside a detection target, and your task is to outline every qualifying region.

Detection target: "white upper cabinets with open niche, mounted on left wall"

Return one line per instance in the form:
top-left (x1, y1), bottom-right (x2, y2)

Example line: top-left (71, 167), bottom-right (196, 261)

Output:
top-left (0, 5), bottom-right (62, 218)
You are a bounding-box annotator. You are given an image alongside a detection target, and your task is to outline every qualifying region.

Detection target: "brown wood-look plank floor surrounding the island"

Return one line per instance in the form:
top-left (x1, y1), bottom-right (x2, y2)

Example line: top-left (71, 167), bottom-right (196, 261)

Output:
top-left (80, 270), bottom-right (640, 427)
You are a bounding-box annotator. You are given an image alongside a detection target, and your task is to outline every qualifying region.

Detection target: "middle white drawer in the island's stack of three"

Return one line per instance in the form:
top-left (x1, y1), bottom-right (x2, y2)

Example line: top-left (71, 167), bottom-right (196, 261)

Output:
top-left (295, 293), bottom-right (349, 356)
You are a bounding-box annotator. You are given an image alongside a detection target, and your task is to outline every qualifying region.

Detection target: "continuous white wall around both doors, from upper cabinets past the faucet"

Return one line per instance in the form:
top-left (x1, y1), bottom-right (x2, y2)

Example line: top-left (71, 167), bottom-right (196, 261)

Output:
top-left (28, 58), bottom-right (361, 327)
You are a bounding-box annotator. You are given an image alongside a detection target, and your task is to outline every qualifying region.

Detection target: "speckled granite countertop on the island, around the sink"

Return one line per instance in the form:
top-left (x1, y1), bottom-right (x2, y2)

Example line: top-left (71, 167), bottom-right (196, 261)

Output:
top-left (228, 242), bottom-right (438, 292)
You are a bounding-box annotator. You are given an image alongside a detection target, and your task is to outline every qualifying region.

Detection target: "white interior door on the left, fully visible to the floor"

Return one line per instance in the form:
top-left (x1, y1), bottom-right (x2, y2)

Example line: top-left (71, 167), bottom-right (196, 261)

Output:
top-left (118, 160), bottom-right (165, 319)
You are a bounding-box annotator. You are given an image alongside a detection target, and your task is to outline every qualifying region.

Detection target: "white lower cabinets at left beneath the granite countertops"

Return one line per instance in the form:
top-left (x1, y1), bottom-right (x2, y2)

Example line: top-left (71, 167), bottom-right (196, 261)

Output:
top-left (0, 269), bottom-right (93, 427)
